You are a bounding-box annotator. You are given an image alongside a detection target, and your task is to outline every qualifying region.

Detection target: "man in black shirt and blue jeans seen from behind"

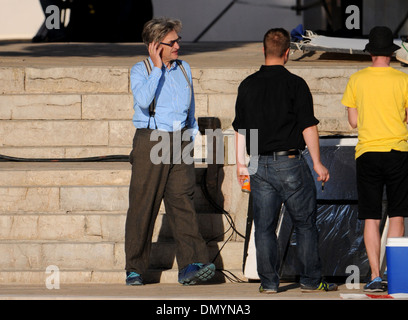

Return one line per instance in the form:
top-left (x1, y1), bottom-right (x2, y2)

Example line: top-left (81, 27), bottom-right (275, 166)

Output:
top-left (232, 28), bottom-right (337, 293)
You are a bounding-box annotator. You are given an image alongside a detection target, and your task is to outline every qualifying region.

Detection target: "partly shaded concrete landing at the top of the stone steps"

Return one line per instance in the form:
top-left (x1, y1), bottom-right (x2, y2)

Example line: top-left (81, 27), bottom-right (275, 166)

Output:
top-left (0, 41), bottom-right (382, 68)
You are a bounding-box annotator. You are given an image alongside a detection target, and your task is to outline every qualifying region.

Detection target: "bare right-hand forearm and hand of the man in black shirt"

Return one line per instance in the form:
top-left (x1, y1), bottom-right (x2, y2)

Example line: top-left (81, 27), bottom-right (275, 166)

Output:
top-left (303, 126), bottom-right (330, 182)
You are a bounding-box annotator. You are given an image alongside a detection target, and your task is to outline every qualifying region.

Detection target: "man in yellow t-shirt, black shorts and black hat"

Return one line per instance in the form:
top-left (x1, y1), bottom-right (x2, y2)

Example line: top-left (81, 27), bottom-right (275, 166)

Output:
top-left (342, 27), bottom-right (408, 292)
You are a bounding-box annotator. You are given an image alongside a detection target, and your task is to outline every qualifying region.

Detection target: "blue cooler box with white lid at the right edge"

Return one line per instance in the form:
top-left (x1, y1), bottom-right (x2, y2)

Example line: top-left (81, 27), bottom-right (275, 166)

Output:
top-left (386, 237), bottom-right (408, 294)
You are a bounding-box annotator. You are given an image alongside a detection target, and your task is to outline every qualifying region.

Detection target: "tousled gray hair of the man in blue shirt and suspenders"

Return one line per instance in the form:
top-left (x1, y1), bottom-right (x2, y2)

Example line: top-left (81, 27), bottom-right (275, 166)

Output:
top-left (142, 17), bottom-right (182, 45)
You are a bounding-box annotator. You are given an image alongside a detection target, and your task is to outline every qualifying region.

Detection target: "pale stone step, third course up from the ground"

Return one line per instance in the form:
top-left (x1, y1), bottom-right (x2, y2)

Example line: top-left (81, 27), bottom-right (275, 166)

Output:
top-left (0, 212), bottom-right (236, 242)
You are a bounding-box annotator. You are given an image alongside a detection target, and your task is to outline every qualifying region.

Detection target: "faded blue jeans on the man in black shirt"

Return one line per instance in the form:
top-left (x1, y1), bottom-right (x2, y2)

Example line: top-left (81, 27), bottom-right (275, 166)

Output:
top-left (251, 156), bottom-right (321, 289)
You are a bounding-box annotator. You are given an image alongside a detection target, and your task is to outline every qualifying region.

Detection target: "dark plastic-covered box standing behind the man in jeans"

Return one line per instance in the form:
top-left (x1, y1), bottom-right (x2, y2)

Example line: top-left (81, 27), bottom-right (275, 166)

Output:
top-left (278, 137), bottom-right (369, 278)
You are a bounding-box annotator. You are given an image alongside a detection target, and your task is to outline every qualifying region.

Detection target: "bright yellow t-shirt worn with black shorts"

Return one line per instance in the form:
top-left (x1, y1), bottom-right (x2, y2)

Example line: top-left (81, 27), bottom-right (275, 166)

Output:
top-left (341, 67), bottom-right (408, 159)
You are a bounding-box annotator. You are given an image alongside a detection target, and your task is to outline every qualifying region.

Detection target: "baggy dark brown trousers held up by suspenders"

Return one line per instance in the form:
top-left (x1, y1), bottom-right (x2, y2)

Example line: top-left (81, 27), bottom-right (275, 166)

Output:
top-left (125, 129), bottom-right (208, 274)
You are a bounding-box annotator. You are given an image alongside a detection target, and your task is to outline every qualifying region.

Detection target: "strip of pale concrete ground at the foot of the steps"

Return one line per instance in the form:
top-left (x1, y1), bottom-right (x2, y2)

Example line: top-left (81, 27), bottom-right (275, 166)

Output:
top-left (0, 282), bottom-right (408, 301)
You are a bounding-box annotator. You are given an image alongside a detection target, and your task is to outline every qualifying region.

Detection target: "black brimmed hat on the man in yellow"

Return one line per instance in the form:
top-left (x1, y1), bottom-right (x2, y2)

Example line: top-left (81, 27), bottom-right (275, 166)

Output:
top-left (364, 27), bottom-right (401, 56)
